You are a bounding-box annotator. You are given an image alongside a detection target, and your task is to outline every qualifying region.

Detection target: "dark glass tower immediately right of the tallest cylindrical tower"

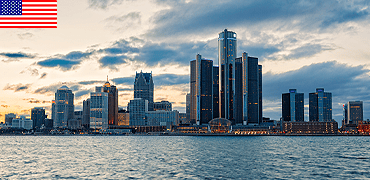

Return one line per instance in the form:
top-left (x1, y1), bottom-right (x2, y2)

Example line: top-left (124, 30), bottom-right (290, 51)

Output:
top-left (242, 52), bottom-right (262, 124)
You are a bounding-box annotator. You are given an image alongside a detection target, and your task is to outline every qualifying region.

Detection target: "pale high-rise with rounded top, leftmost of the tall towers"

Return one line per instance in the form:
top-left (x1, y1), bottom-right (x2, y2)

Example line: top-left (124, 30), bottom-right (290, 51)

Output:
top-left (52, 86), bottom-right (74, 128)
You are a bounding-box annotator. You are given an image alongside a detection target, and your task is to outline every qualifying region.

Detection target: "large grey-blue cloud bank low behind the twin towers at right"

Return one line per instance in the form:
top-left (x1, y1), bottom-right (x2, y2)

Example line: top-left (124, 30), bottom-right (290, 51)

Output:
top-left (263, 61), bottom-right (370, 120)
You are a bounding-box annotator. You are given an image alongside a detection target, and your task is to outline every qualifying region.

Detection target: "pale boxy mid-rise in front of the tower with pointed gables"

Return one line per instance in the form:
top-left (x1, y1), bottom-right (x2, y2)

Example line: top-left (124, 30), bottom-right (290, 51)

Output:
top-left (129, 98), bottom-right (148, 126)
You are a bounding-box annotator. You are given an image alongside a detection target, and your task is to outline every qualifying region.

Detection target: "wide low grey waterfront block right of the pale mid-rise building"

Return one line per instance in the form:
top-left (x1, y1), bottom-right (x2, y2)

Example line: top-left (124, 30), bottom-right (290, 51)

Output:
top-left (145, 110), bottom-right (180, 126)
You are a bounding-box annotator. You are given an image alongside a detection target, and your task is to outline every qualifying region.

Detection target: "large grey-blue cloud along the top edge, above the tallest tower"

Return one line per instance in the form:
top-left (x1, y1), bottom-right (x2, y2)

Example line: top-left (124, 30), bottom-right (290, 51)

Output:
top-left (148, 0), bottom-right (369, 38)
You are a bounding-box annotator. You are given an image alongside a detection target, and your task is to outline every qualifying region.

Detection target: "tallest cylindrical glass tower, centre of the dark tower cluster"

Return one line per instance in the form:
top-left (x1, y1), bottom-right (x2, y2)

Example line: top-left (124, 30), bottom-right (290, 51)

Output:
top-left (218, 29), bottom-right (237, 123)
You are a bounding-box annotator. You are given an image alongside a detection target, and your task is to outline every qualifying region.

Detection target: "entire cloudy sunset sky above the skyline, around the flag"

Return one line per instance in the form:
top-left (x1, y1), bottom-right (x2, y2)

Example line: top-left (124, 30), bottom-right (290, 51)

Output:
top-left (0, 0), bottom-right (370, 125)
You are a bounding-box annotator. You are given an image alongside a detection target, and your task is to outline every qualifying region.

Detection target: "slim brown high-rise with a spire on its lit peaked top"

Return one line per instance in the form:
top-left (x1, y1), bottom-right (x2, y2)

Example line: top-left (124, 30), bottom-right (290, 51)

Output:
top-left (95, 77), bottom-right (118, 125)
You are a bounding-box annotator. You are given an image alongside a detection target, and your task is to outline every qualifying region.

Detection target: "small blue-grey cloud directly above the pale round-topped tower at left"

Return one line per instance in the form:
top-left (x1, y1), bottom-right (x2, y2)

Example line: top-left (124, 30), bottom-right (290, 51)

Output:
top-left (36, 51), bottom-right (94, 71)
